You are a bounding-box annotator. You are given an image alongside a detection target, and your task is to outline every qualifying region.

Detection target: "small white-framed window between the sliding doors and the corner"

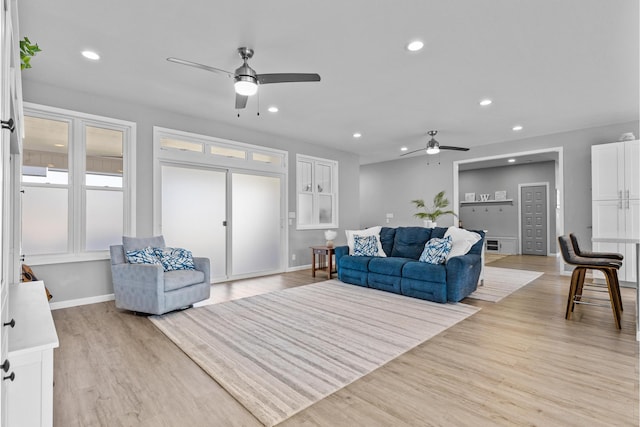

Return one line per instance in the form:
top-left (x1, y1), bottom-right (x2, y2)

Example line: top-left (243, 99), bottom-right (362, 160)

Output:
top-left (296, 154), bottom-right (338, 229)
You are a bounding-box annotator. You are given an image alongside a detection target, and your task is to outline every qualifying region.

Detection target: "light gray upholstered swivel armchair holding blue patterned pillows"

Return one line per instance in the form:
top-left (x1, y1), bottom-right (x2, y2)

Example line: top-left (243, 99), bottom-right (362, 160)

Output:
top-left (109, 236), bottom-right (211, 314)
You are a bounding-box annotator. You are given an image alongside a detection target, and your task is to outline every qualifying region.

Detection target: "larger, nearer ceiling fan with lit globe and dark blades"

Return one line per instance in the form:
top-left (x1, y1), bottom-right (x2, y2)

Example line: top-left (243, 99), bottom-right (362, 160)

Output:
top-left (167, 47), bottom-right (320, 109)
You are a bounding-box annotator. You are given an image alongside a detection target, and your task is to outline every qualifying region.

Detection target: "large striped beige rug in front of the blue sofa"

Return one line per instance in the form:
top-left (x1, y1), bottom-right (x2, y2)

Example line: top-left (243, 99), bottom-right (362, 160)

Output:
top-left (150, 280), bottom-right (479, 426)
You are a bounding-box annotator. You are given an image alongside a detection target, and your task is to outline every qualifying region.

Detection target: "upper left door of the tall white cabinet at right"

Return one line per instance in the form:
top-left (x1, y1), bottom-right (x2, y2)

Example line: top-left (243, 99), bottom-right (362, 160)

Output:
top-left (591, 142), bottom-right (624, 200)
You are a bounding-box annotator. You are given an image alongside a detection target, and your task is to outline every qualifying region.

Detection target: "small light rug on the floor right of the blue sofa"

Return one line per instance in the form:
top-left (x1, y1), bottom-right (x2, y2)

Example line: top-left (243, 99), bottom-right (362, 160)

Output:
top-left (469, 265), bottom-right (543, 302)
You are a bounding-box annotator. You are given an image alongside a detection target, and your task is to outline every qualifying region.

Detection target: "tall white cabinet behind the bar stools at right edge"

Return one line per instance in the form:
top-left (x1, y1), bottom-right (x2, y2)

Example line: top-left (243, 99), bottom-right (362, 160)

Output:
top-left (591, 141), bottom-right (640, 282)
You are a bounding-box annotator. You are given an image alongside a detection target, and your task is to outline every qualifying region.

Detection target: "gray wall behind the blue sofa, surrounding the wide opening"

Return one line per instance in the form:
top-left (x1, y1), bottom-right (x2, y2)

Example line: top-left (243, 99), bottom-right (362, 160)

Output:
top-left (360, 121), bottom-right (639, 254)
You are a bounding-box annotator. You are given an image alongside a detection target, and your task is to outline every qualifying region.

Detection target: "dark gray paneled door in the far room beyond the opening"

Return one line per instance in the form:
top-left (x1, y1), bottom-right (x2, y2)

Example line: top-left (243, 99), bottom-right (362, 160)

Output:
top-left (520, 185), bottom-right (549, 256)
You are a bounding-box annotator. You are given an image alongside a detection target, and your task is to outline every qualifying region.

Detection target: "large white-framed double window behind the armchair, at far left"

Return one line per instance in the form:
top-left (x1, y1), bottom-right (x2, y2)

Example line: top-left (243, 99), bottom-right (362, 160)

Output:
top-left (22, 105), bottom-right (135, 264)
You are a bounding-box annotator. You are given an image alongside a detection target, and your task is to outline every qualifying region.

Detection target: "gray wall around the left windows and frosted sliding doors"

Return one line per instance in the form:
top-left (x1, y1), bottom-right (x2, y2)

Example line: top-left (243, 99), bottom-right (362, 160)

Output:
top-left (23, 80), bottom-right (359, 302)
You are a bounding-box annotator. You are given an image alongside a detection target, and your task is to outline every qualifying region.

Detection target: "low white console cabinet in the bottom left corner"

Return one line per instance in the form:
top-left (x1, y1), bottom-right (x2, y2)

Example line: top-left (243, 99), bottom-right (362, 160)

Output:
top-left (4, 281), bottom-right (58, 427)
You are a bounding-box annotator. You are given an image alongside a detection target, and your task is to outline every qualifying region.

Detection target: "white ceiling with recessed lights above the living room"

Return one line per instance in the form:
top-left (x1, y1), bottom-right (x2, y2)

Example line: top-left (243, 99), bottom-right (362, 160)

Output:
top-left (18, 0), bottom-right (639, 164)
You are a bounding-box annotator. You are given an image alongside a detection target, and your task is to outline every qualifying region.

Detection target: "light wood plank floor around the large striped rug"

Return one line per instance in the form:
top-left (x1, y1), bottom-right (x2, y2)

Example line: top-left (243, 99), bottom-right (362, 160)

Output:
top-left (53, 256), bottom-right (639, 427)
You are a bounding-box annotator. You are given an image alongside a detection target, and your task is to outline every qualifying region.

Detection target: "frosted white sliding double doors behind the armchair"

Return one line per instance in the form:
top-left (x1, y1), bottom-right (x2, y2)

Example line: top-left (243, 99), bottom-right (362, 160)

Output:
top-left (161, 164), bottom-right (286, 282)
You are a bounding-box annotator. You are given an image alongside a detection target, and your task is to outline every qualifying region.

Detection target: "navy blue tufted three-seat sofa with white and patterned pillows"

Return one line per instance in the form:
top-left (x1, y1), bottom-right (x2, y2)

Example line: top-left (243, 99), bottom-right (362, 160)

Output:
top-left (335, 227), bottom-right (484, 303)
